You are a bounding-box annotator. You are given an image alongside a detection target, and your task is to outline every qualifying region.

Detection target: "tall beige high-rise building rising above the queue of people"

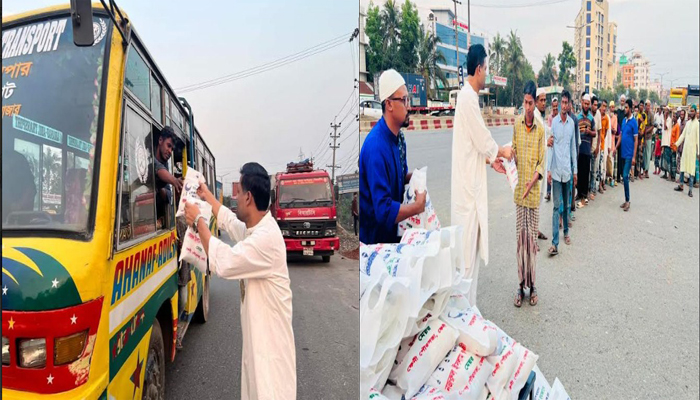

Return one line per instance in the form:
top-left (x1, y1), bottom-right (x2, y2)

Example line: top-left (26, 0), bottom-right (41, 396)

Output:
top-left (574, 0), bottom-right (617, 93)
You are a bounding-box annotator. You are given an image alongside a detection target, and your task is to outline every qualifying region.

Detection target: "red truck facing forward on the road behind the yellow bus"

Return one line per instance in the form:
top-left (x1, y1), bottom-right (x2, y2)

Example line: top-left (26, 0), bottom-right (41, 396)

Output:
top-left (271, 160), bottom-right (340, 262)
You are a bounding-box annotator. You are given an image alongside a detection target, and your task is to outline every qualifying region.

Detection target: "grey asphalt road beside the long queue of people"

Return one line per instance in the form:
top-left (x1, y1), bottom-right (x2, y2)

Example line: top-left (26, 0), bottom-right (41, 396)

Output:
top-left (378, 128), bottom-right (700, 399)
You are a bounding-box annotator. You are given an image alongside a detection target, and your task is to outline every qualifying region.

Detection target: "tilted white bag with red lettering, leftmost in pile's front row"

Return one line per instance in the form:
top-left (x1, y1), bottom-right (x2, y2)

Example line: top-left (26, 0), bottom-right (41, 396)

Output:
top-left (389, 320), bottom-right (458, 398)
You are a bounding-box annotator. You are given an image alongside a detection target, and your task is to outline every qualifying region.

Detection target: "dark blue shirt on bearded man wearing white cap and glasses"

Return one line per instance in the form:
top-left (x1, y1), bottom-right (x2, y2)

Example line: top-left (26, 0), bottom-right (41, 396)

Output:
top-left (360, 117), bottom-right (408, 244)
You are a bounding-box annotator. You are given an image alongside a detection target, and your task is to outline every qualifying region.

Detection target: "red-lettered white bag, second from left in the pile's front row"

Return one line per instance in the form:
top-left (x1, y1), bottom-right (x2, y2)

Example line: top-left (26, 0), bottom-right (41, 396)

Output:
top-left (428, 342), bottom-right (493, 400)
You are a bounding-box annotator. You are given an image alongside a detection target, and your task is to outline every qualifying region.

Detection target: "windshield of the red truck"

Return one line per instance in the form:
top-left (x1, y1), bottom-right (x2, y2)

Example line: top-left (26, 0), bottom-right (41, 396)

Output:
top-left (279, 178), bottom-right (333, 208)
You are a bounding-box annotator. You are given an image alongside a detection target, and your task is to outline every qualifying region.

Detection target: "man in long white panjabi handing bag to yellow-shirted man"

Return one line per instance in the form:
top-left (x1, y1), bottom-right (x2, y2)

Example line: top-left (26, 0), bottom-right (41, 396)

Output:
top-left (451, 44), bottom-right (512, 305)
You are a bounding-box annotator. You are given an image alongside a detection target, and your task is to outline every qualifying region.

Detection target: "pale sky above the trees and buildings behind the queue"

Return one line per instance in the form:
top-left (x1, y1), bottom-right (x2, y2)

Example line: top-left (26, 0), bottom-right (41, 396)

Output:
top-left (360, 0), bottom-right (700, 88)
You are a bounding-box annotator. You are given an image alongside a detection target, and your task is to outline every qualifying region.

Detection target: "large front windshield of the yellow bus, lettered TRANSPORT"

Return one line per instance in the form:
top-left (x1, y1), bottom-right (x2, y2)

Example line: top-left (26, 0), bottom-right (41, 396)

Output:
top-left (2, 16), bottom-right (110, 232)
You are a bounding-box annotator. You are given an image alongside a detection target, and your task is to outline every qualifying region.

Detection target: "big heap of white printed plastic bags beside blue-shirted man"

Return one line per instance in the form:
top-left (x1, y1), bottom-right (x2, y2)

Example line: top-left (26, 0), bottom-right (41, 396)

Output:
top-left (360, 169), bottom-right (569, 400)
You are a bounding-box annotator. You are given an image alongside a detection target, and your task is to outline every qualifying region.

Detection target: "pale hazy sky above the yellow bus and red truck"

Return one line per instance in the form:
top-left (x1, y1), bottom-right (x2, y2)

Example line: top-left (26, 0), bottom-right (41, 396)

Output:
top-left (2, 0), bottom-right (359, 193)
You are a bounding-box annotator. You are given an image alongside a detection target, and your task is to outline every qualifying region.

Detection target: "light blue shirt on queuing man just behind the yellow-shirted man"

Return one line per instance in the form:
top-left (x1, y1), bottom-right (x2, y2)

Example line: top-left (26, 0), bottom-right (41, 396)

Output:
top-left (549, 115), bottom-right (578, 182)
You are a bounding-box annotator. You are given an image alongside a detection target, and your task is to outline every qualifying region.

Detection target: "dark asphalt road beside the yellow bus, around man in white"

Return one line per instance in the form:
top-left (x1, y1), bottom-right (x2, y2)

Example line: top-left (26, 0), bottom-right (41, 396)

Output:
top-left (165, 233), bottom-right (360, 399)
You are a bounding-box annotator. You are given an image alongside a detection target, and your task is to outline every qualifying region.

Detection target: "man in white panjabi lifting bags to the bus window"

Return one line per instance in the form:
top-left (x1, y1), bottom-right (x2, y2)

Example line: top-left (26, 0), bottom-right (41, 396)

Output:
top-left (185, 163), bottom-right (297, 400)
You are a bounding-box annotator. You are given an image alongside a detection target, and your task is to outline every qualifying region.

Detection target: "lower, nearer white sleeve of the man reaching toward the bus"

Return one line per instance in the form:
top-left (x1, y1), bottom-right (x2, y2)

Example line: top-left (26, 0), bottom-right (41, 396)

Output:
top-left (209, 234), bottom-right (273, 279)
